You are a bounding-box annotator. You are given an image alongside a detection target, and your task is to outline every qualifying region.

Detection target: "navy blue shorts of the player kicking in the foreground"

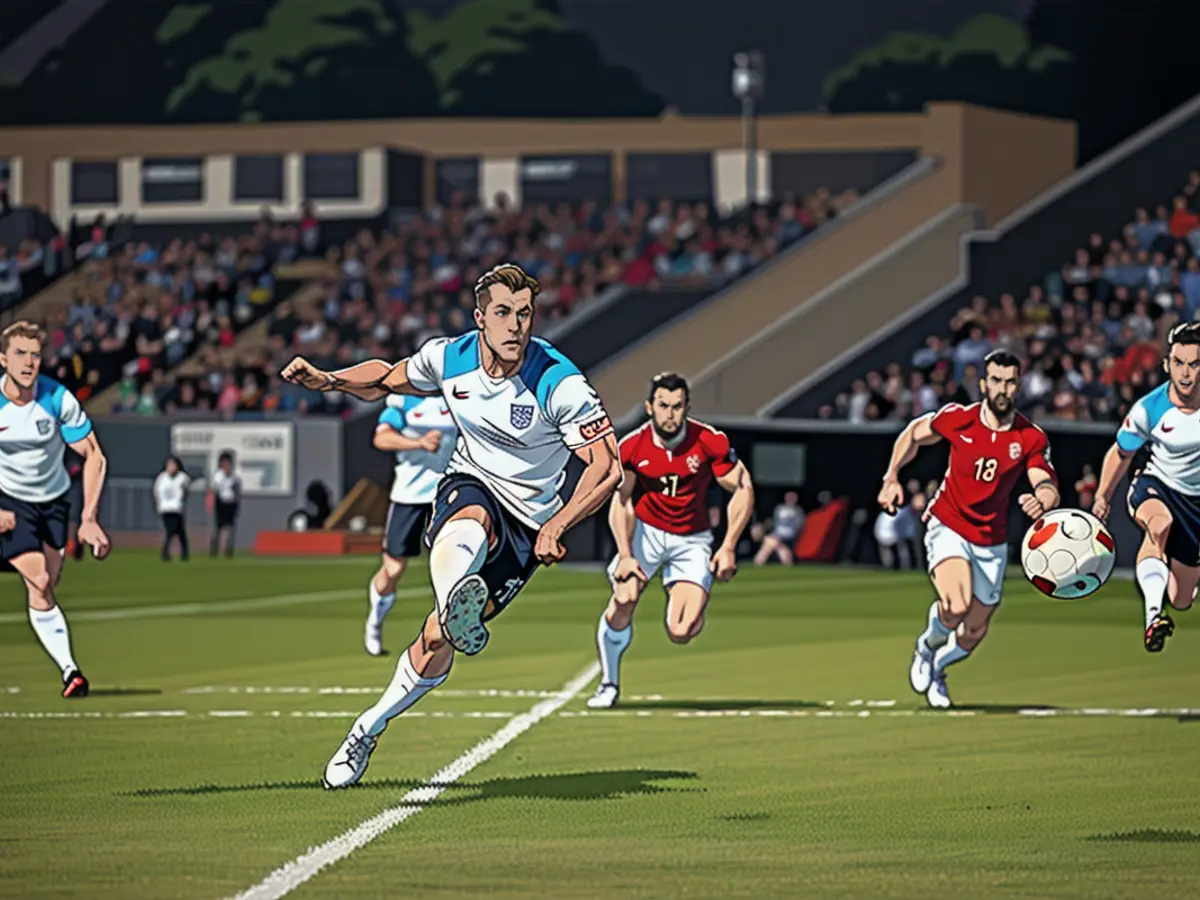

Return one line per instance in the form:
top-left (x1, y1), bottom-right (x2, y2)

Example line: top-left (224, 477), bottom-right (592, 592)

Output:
top-left (425, 474), bottom-right (539, 622)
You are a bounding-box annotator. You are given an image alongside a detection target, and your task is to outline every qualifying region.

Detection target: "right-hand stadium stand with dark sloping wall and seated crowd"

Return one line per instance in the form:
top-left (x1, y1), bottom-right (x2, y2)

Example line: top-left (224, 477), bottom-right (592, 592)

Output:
top-left (758, 90), bottom-right (1200, 424)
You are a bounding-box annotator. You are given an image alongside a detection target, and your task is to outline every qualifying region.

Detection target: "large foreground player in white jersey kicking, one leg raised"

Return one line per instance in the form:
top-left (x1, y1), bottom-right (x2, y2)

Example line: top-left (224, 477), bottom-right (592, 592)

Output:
top-left (282, 265), bottom-right (622, 787)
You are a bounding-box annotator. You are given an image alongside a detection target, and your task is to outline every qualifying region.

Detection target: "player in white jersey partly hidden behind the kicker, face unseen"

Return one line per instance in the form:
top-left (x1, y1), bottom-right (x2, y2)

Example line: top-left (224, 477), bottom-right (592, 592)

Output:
top-left (366, 394), bottom-right (458, 656)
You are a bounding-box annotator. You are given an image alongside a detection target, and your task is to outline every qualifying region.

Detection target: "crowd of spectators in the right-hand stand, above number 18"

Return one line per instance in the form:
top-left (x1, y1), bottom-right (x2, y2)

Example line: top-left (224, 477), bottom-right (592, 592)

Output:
top-left (820, 172), bottom-right (1200, 422)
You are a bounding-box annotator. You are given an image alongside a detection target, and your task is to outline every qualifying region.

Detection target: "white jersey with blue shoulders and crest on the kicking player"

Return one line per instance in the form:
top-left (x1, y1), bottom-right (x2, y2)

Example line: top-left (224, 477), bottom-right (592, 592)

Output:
top-left (408, 331), bottom-right (612, 528)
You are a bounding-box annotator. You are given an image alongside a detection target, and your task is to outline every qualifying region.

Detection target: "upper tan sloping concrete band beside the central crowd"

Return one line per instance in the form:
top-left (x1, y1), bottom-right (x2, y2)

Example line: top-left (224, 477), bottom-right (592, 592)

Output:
top-left (593, 160), bottom-right (961, 420)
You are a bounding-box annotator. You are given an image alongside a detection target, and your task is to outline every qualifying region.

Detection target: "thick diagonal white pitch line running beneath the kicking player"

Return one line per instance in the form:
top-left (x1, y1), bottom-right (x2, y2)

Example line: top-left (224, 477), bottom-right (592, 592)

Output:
top-left (225, 662), bottom-right (600, 900)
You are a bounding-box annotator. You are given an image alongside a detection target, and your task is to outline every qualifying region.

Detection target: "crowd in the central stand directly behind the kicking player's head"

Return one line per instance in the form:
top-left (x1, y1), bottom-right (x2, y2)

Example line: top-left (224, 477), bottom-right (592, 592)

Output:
top-left (121, 191), bottom-right (857, 415)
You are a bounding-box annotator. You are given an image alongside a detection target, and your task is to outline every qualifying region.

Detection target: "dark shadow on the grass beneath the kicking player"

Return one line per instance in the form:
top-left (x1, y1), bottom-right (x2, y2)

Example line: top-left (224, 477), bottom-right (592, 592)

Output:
top-left (121, 769), bottom-right (702, 806)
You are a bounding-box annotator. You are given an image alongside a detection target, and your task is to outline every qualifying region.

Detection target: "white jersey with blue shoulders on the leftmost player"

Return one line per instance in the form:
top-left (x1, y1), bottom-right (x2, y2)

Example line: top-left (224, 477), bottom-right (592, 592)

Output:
top-left (0, 376), bottom-right (91, 503)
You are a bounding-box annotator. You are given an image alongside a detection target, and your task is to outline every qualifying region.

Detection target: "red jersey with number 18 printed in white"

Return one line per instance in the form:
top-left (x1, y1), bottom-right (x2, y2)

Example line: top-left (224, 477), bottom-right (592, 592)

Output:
top-left (931, 403), bottom-right (1058, 546)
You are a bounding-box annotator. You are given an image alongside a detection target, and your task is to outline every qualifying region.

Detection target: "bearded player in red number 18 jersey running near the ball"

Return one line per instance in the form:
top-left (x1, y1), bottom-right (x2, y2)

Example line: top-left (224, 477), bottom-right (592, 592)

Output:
top-left (878, 350), bottom-right (1058, 709)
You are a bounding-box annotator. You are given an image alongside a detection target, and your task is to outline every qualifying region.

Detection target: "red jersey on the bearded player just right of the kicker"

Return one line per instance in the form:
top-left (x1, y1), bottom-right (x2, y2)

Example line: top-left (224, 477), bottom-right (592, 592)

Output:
top-left (620, 419), bottom-right (737, 534)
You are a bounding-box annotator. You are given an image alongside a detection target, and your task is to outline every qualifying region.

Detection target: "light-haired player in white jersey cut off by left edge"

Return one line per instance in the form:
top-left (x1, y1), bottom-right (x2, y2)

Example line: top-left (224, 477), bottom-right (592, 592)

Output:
top-left (0, 322), bottom-right (110, 698)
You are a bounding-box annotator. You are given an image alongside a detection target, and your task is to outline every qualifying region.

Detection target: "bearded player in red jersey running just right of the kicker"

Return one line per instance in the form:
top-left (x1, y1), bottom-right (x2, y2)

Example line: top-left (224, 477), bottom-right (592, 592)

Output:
top-left (588, 372), bottom-right (754, 709)
